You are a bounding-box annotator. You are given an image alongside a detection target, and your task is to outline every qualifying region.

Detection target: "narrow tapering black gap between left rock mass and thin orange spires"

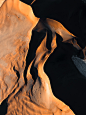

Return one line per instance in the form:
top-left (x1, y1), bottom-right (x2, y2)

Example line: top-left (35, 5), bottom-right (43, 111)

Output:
top-left (24, 30), bottom-right (46, 84)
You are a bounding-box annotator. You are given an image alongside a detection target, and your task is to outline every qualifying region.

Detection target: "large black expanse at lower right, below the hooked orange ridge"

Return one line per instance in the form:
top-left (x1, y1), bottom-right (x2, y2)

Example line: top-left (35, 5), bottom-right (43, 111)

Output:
top-left (44, 34), bottom-right (86, 115)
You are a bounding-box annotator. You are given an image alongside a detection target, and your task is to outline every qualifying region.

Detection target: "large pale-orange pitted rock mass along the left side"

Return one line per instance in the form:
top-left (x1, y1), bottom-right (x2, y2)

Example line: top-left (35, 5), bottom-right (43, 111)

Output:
top-left (0, 0), bottom-right (38, 103)
